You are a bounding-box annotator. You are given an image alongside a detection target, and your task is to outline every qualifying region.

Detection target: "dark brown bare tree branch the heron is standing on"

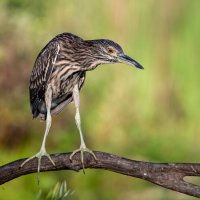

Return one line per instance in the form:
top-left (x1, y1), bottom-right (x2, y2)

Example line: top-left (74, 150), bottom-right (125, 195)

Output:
top-left (0, 151), bottom-right (200, 197)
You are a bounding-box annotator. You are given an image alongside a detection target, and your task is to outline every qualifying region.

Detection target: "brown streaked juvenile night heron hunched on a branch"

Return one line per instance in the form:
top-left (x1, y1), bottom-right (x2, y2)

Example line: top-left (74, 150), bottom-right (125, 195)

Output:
top-left (21, 33), bottom-right (143, 172)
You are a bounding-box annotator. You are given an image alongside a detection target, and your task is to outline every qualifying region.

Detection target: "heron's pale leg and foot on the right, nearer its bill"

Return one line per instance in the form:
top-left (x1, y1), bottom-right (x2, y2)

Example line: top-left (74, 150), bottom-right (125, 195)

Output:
top-left (70, 84), bottom-right (97, 169)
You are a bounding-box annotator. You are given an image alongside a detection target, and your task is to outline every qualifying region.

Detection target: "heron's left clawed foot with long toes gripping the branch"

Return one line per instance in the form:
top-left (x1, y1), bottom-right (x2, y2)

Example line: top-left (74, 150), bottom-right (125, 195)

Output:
top-left (21, 148), bottom-right (55, 185)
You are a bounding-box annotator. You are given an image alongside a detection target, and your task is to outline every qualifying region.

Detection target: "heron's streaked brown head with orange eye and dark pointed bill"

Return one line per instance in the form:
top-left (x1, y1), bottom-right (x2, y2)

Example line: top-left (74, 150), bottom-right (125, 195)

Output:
top-left (86, 39), bottom-right (144, 69)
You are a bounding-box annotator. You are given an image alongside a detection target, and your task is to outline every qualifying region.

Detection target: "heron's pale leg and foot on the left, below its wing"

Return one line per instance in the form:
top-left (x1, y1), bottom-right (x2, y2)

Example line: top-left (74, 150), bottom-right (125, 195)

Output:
top-left (21, 86), bottom-right (55, 183)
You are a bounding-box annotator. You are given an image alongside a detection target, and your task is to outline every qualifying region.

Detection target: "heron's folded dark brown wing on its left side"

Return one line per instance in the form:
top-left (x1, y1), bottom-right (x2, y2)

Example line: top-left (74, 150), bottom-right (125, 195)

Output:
top-left (29, 40), bottom-right (60, 117)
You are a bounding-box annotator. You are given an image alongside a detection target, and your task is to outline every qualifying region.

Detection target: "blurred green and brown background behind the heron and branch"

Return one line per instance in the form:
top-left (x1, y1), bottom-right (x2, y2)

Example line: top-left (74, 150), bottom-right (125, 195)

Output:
top-left (0, 0), bottom-right (200, 200)
